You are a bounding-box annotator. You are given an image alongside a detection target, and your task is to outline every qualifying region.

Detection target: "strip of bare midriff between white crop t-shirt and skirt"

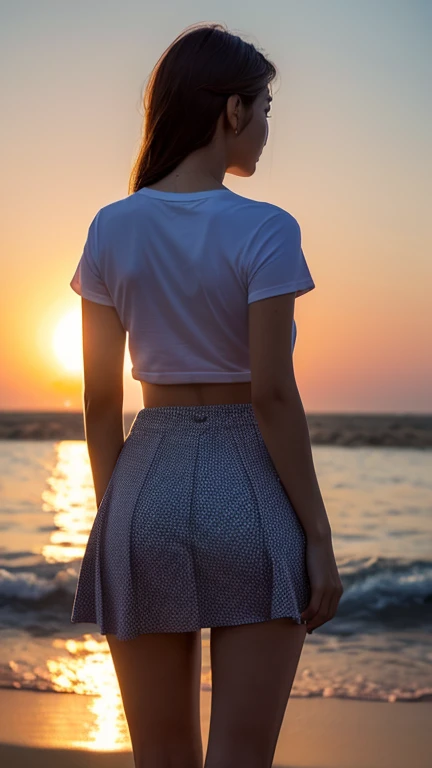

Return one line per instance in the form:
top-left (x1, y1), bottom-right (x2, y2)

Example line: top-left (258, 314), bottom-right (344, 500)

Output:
top-left (141, 381), bottom-right (251, 408)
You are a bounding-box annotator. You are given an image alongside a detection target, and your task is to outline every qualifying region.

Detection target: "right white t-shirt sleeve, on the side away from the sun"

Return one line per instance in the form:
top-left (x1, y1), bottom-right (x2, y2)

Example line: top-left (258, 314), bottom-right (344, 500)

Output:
top-left (248, 209), bottom-right (315, 304)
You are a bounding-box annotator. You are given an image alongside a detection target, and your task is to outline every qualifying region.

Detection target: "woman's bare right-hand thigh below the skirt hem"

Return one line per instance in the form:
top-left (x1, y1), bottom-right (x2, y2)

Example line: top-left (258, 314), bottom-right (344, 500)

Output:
top-left (205, 618), bottom-right (306, 768)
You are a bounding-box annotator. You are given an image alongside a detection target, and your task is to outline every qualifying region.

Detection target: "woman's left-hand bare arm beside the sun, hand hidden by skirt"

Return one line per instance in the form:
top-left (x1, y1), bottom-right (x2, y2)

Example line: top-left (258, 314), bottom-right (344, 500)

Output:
top-left (81, 298), bottom-right (126, 507)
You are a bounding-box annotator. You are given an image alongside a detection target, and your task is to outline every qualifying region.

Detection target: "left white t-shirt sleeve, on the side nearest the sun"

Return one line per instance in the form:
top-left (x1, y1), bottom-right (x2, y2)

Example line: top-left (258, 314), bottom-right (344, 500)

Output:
top-left (69, 213), bottom-right (114, 307)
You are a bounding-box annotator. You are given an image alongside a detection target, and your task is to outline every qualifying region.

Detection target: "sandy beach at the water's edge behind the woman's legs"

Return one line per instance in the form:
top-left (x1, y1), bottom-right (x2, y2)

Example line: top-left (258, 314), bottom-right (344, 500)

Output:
top-left (0, 690), bottom-right (432, 768)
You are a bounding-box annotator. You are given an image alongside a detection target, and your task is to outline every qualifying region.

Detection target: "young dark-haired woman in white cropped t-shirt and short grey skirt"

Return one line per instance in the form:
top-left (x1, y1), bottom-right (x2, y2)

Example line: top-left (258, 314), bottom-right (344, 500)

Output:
top-left (71, 24), bottom-right (342, 768)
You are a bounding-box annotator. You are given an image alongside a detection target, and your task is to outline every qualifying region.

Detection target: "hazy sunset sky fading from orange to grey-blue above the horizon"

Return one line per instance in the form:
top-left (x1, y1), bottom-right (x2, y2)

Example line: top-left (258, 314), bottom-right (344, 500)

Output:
top-left (0, 0), bottom-right (432, 413)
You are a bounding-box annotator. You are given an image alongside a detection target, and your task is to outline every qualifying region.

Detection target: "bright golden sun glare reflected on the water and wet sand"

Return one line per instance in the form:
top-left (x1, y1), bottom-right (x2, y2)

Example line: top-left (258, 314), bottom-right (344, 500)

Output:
top-left (39, 440), bottom-right (130, 751)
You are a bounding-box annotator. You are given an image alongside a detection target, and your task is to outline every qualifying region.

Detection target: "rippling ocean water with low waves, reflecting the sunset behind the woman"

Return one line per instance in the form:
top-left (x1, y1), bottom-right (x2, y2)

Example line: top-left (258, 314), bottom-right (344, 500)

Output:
top-left (0, 440), bottom-right (432, 712)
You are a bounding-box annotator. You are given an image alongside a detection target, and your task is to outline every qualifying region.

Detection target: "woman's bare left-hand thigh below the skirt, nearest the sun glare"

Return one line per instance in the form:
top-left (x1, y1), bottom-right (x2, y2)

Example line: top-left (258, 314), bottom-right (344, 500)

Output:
top-left (106, 631), bottom-right (203, 768)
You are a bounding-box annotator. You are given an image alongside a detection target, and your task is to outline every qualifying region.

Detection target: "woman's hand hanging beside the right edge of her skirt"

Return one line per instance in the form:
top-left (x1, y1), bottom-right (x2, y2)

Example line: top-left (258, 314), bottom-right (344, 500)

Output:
top-left (301, 537), bottom-right (343, 634)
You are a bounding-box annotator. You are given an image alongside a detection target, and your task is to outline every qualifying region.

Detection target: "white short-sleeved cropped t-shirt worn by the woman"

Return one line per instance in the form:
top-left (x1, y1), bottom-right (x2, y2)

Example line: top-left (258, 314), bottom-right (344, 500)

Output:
top-left (70, 187), bottom-right (315, 384)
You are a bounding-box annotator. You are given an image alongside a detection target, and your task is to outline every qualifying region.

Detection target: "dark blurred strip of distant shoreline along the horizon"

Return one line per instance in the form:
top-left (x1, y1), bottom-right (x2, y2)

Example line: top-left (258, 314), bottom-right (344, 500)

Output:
top-left (0, 411), bottom-right (432, 449)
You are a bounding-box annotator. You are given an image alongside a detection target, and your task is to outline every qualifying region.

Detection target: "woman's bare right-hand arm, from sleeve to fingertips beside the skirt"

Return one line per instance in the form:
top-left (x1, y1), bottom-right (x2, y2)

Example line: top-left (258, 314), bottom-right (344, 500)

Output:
top-left (249, 293), bottom-right (343, 631)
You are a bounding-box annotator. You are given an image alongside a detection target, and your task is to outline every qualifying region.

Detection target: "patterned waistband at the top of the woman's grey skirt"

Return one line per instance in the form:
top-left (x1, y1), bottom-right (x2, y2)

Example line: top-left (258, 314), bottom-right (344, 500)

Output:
top-left (133, 403), bottom-right (257, 431)
